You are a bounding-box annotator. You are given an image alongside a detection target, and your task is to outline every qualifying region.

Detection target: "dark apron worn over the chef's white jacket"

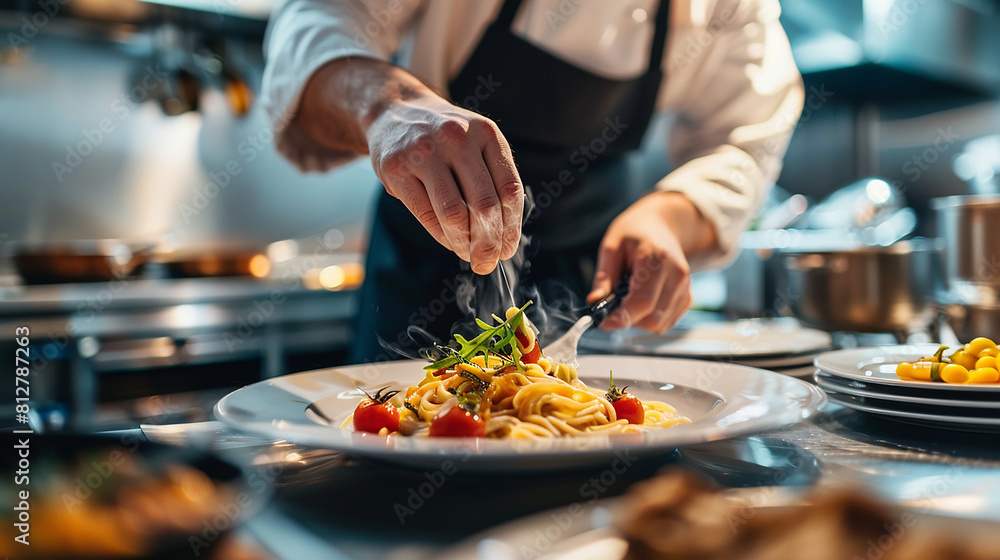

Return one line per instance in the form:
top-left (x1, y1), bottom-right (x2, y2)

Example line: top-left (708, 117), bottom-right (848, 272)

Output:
top-left (349, 0), bottom-right (669, 363)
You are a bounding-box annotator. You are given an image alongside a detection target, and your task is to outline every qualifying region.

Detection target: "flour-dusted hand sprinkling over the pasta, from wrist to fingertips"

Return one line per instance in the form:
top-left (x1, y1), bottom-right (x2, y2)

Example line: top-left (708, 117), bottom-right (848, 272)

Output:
top-left (367, 92), bottom-right (524, 274)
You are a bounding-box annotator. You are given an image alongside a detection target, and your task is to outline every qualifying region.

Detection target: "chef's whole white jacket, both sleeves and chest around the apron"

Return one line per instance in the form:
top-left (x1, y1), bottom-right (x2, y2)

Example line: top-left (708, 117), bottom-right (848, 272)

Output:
top-left (261, 0), bottom-right (804, 268)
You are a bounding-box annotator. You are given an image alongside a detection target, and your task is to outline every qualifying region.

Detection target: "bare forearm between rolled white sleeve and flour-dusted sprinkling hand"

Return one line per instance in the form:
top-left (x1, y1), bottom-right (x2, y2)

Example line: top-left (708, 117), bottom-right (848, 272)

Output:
top-left (294, 57), bottom-right (437, 154)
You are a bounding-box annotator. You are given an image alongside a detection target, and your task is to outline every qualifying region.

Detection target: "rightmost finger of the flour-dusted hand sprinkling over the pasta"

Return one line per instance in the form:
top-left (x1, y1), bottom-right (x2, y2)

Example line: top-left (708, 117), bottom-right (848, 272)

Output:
top-left (477, 121), bottom-right (524, 260)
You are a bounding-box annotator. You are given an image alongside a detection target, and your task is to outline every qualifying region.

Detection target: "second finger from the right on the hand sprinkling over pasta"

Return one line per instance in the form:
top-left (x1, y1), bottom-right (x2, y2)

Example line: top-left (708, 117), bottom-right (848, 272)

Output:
top-left (448, 144), bottom-right (503, 274)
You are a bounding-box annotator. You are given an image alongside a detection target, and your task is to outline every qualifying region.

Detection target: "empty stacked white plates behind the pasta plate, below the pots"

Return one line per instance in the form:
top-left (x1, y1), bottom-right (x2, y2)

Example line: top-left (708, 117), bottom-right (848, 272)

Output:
top-left (580, 317), bottom-right (831, 377)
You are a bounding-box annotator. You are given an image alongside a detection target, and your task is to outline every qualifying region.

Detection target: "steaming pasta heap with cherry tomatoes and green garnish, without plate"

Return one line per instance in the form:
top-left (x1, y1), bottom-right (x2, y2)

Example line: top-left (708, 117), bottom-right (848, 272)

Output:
top-left (341, 302), bottom-right (690, 439)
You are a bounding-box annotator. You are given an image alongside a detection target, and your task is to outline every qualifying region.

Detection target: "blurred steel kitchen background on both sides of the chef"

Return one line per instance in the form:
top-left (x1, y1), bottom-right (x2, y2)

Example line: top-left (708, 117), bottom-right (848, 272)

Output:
top-left (0, 0), bottom-right (1000, 427)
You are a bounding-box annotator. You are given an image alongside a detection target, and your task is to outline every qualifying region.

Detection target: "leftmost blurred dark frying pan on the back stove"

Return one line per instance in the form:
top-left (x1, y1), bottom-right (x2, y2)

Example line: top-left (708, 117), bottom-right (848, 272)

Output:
top-left (12, 239), bottom-right (153, 285)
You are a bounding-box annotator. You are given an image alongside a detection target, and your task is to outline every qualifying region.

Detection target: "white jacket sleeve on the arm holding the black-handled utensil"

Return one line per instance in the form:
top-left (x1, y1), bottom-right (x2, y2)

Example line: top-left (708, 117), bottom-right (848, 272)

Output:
top-left (657, 0), bottom-right (804, 269)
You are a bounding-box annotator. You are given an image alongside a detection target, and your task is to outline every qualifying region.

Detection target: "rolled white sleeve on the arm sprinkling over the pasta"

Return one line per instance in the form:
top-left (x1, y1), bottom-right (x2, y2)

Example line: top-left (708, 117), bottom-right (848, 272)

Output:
top-left (261, 0), bottom-right (421, 171)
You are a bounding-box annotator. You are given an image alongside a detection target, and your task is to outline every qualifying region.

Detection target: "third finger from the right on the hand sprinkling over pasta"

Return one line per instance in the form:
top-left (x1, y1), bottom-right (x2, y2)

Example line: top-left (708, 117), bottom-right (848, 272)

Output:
top-left (416, 159), bottom-right (471, 261)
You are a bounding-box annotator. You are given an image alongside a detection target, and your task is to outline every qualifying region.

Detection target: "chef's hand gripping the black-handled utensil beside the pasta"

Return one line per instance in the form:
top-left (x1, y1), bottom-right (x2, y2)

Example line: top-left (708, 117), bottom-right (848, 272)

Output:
top-left (587, 192), bottom-right (717, 334)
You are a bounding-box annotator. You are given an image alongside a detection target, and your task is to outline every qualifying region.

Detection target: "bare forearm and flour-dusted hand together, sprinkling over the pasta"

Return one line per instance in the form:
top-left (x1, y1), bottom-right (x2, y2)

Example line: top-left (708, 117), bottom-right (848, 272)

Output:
top-left (293, 57), bottom-right (524, 274)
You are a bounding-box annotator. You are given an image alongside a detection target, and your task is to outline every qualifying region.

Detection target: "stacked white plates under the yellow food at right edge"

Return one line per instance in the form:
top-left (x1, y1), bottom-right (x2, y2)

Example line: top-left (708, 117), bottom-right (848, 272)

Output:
top-left (816, 344), bottom-right (1000, 433)
